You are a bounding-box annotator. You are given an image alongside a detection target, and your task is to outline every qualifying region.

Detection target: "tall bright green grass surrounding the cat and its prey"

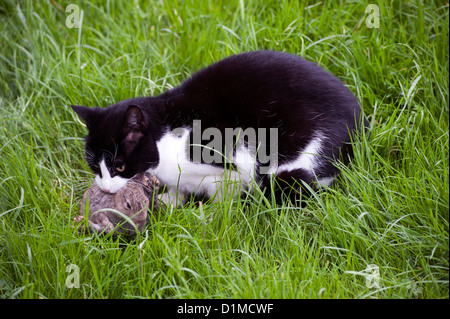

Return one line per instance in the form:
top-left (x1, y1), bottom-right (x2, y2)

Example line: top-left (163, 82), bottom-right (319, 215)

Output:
top-left (0, 0), bottom-right (449, 298)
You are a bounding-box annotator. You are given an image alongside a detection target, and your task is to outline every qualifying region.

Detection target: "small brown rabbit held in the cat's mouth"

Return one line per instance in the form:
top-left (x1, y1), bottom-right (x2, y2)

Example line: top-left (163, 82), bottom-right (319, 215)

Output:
top-left (75, 172), bottom-right (159, 235)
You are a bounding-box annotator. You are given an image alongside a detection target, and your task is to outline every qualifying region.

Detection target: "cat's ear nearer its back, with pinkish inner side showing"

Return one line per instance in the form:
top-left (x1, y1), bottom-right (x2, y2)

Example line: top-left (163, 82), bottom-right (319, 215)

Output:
top-left (123, 105), bottom-right (146, 154)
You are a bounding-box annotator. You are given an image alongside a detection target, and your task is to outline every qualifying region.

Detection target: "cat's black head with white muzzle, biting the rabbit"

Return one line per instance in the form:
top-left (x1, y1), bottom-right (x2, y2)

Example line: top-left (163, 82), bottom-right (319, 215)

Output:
top-left (72, 102), bottom-right (159, 193)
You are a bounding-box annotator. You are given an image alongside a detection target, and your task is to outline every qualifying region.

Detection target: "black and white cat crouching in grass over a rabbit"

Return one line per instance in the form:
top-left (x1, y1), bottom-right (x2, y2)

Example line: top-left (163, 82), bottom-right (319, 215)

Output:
top-left (72, 51), bottom-right (361, 203)
